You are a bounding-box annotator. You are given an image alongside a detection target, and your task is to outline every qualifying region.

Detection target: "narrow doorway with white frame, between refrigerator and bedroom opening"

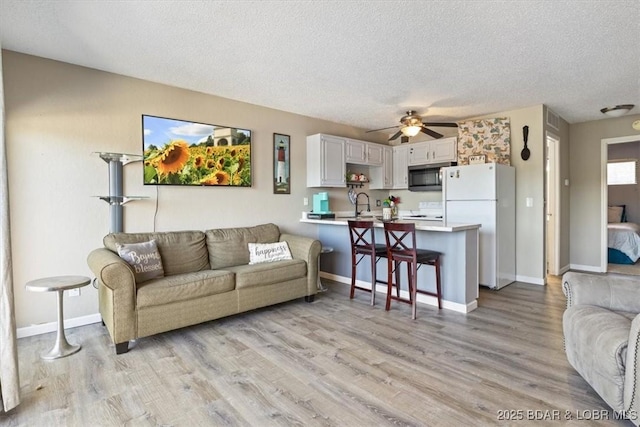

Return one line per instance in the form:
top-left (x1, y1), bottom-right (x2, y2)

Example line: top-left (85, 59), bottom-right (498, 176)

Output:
top-left (544, 131), bottom-right (560, 276)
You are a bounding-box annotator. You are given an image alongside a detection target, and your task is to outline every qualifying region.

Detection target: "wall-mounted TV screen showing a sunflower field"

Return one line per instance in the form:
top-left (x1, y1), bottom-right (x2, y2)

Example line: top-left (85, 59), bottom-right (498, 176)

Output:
top-left (142, 115), bottom-right (251, 187)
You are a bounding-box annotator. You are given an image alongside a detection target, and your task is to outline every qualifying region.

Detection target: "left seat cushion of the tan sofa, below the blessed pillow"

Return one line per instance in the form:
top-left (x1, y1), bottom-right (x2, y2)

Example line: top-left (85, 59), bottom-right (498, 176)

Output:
top-left (137, 270), bottom-right (234, 308)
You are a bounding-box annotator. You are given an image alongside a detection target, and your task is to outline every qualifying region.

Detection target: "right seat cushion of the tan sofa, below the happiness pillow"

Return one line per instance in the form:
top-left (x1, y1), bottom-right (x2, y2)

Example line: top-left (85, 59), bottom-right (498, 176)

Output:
top-left (227, 259), bottom-right (307, 289)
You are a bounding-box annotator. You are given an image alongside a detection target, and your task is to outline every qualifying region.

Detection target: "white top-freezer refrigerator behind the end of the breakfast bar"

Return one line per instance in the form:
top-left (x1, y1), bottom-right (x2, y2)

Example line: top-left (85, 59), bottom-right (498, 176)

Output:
top-left (442, 163), bottom-right (516, 290)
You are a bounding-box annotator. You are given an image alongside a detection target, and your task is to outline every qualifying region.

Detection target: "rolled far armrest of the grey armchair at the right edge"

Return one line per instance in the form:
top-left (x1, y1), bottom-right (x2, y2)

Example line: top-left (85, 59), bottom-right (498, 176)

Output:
top-left (562, 272), bottom-right (640, 313)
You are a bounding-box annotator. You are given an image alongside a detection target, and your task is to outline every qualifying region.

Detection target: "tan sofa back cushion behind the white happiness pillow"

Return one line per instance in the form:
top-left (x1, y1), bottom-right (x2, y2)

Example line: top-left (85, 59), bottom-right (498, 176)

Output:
top-left (205, 224), bottom-right (280, 270)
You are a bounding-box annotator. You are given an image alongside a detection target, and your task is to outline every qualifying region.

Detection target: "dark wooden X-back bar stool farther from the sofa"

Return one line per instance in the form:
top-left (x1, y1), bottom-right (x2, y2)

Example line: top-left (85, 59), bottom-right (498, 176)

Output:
top-left (384, 222), bottom-right (442, 319)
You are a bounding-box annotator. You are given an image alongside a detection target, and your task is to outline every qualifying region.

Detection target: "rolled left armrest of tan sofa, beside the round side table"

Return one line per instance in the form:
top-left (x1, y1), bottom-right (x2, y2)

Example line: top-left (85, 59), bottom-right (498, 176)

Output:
top-left (87, 248), bottom-right (137, 344)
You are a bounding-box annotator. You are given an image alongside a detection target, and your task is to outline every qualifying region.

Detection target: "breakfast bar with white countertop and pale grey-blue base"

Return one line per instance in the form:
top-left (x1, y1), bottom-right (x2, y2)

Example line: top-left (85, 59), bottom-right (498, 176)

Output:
top-left (300, 216), bottom-right (480, 313)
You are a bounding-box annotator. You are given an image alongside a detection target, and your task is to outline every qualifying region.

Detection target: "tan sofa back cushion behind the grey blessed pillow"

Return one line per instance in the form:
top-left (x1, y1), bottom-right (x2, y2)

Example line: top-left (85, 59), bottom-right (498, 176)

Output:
top-left (103, 231), bottom-right (210, 276)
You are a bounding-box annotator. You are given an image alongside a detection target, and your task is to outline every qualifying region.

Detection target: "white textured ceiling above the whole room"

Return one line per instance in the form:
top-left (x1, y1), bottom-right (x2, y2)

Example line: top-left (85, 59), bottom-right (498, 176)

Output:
top-left (0, 0), bottom-right (640, 129)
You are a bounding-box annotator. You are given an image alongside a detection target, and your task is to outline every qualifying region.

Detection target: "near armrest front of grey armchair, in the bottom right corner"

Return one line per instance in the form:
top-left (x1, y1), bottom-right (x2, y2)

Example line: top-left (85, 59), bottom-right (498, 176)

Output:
top-left (623, 314), bottom-right (640, 425)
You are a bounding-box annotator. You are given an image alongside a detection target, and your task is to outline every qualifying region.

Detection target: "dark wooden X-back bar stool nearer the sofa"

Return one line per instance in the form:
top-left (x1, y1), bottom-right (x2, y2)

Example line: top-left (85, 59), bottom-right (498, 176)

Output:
top-left (349, 221), bottom-right (387, 305)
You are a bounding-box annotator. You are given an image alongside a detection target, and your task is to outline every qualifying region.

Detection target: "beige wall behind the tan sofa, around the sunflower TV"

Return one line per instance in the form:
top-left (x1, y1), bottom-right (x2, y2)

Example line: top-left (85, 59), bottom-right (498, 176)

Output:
top-left (2, 50), bottom-right (388, 328)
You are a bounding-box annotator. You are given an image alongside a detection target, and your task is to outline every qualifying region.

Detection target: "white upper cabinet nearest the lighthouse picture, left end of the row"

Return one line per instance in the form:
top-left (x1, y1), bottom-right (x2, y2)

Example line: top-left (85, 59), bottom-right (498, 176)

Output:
top-left (307, 133), bottom-right (347, 187)
